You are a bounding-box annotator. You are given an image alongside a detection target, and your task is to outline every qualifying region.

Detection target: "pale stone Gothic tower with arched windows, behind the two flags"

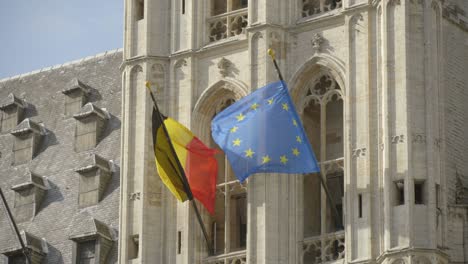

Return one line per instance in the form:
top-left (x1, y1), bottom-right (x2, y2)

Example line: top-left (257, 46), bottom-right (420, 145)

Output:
top-left (119, 0), bottom-right (468, 264)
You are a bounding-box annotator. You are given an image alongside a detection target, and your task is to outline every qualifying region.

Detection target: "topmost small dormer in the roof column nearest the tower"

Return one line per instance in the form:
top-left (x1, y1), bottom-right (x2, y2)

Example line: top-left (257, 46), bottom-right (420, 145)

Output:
top-left (62, 78), bottom-right (90, 116)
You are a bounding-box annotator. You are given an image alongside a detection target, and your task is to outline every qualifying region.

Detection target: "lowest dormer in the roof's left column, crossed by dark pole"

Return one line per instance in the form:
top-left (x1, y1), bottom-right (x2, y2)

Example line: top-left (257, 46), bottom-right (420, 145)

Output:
top-left (1, 231), bottom-right (48, 264)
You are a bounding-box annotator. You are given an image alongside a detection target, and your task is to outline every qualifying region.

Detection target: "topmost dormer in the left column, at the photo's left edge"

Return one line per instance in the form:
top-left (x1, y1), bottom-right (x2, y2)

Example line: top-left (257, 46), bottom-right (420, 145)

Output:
top-left (0, 93), bottom-right (26, 132)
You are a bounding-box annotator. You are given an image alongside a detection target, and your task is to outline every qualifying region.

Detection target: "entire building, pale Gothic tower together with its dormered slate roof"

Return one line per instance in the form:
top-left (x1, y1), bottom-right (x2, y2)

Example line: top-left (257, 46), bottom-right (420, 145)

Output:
top-left (0, 0), bottom-right (468, 264)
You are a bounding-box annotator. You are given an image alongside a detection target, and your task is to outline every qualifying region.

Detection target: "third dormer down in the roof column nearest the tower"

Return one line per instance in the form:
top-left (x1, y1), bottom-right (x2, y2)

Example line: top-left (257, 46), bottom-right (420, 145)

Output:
top-left (75, 154), bottom-right (112, 208)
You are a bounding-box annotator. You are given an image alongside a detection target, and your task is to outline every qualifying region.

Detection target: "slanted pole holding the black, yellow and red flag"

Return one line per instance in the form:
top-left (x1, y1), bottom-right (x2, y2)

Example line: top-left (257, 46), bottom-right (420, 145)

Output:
top-left (146, 82), bottom-right (214, 255)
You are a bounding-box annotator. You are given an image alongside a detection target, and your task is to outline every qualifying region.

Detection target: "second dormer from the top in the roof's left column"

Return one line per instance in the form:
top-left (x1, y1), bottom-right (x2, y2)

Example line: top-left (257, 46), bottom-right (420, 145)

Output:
top-left (10, 118), bottom-right (45, 165)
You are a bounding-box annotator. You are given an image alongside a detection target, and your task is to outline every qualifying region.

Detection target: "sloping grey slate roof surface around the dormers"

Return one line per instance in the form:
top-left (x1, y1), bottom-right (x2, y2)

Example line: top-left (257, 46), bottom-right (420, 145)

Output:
top-left (0, 50), bottom-right (122, 263)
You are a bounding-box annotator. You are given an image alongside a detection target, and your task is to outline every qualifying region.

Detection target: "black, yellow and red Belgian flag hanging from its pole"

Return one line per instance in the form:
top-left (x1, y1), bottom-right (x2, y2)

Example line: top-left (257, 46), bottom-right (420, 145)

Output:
top-left (152, 108), bottom-right (218, 214)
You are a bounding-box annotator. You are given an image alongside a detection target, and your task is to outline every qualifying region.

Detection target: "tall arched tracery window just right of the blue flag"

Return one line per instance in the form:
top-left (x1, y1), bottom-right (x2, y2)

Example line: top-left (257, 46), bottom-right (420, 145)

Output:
top-left (302, 70), bottom-right (344, 264)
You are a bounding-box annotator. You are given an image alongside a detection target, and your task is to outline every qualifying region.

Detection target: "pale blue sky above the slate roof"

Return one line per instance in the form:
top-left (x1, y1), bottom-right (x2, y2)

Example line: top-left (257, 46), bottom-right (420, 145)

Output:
top-left (0, 0), bottom-right (124, 79)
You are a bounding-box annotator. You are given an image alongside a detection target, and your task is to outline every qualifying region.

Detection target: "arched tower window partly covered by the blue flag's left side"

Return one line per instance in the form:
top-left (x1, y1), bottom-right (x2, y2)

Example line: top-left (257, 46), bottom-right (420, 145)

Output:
top-left (193, 81), bottom-right (247, 263)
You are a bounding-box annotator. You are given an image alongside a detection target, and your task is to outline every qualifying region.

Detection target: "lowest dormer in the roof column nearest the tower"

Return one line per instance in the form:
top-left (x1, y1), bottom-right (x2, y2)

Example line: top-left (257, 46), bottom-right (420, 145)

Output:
top-left (68, 216), bottom-right (114, 264)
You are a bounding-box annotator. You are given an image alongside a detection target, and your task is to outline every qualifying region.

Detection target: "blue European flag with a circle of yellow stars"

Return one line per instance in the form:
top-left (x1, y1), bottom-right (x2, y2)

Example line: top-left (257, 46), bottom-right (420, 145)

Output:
top-left (211, 81), bottom-right (320, 182)
